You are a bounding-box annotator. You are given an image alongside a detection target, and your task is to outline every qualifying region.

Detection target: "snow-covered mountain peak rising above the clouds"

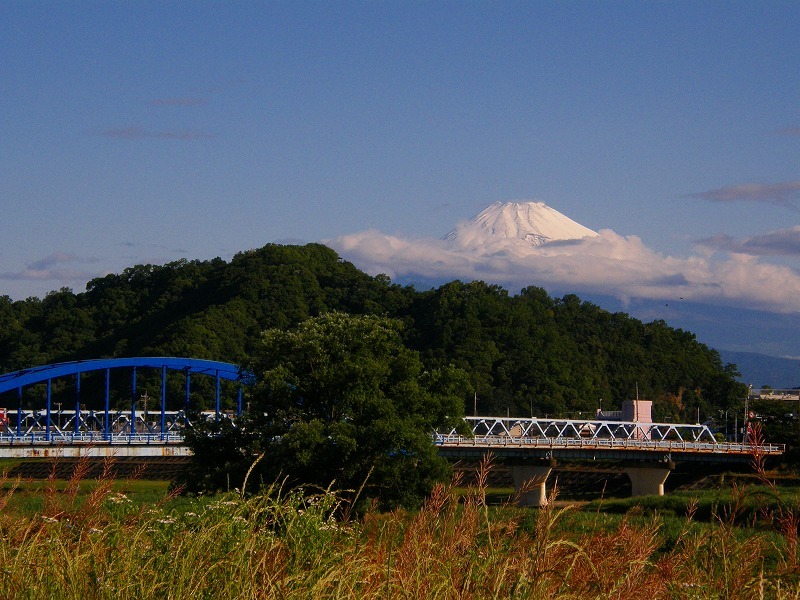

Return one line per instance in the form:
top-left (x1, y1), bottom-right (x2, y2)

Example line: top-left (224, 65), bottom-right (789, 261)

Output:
top-left (444, 202), bottom-right (599, 247)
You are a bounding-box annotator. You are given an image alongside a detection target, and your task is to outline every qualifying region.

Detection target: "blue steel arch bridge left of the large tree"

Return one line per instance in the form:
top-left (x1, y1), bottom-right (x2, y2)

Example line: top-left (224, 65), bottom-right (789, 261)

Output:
top-left (0, 357), bottom-right (253, 455)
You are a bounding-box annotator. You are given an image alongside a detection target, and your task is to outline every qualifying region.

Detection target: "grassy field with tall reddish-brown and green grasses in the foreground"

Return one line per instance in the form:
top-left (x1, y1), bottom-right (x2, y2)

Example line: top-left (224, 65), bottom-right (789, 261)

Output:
top-left (0, 464), bottom-right (800, 599)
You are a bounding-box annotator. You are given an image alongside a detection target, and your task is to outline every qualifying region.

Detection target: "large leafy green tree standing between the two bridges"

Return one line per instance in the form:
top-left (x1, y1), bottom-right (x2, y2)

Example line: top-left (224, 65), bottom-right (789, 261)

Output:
top-left (181, 312), bottom-right (470, 508)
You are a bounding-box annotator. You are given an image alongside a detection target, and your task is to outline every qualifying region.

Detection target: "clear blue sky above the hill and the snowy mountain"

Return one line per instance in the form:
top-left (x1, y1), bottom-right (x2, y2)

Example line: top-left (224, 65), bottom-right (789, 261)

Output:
top-left (0, 0), bottom-right (800, 355)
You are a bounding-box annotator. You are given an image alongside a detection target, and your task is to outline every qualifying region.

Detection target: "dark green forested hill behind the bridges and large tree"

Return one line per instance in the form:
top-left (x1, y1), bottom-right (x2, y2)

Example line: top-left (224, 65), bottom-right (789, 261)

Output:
top-left (0, 244), bottom-right (744, 421)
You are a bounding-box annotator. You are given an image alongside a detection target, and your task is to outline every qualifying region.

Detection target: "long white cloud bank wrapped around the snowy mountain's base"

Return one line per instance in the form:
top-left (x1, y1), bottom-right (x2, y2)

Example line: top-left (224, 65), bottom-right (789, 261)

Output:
top-left (326, 229), bottom-right (800, 313)
